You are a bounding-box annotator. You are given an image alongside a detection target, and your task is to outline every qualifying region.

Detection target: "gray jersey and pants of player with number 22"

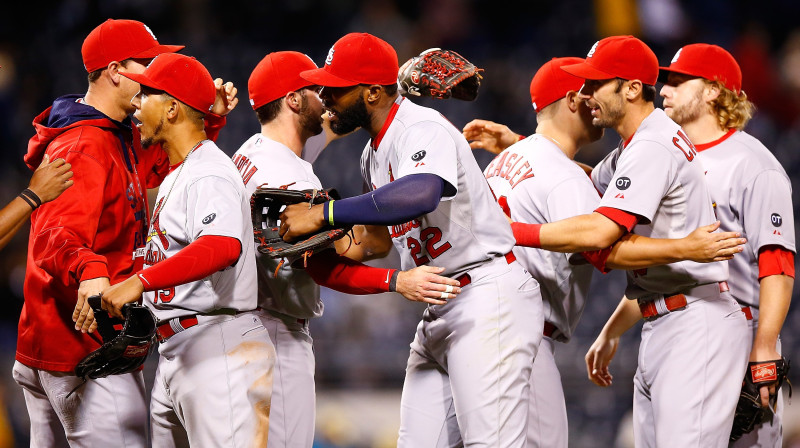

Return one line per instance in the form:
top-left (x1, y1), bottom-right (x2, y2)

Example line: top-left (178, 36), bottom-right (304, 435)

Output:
top-left (361, 97), bottom-right (543, 448)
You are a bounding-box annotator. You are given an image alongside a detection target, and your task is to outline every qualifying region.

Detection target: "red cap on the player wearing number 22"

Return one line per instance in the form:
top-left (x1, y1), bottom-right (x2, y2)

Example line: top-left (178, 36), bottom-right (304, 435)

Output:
top-left (300, 33), bottom-right (400, 87)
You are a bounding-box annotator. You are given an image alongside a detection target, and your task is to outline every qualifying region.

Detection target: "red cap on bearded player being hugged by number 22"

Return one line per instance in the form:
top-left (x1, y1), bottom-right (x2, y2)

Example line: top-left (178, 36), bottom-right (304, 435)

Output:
top-left (247, 51), bottom-right (317, 110)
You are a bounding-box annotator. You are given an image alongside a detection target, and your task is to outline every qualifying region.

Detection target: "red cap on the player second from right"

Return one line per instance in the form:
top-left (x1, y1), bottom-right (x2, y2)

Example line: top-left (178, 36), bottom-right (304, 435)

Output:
top-left (562, 36), bottom-right (658, 85)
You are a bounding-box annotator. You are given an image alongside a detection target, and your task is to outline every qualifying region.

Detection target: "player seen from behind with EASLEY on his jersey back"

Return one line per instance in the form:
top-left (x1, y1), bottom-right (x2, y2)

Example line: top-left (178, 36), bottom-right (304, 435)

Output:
top-left (476, 58), bottom-right (740, 447)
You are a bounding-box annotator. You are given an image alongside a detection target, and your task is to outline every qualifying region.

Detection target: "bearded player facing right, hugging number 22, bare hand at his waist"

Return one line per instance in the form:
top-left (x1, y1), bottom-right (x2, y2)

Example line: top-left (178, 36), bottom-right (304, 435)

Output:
top-left (233, 51), bottom-right (459, 447)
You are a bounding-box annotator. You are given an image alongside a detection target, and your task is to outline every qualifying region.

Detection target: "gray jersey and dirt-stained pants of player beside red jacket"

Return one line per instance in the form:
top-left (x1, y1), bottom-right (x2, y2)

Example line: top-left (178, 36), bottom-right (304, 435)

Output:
top-left (145, 140), bottom-right (275, 447)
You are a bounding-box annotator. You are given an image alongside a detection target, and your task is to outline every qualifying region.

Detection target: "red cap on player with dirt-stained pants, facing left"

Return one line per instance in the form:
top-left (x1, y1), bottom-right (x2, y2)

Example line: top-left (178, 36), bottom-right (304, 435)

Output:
top-left (120, 53), bottom-right (217, 113)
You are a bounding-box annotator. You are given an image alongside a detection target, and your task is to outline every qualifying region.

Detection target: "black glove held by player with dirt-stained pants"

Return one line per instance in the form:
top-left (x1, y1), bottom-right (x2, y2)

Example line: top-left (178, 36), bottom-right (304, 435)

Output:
top-left (75, 295), bottom-right (156, 381)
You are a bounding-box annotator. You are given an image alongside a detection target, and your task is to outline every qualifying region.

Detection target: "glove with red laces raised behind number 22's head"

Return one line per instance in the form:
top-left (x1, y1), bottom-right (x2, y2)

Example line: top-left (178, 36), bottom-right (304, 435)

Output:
top-left (397, 48), bottom-right (483, 101)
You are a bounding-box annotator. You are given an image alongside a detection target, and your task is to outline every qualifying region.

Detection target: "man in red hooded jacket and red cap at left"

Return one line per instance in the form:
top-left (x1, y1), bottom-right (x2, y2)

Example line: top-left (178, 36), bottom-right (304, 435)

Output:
top-left (13, 20), bottom-right (189, 447)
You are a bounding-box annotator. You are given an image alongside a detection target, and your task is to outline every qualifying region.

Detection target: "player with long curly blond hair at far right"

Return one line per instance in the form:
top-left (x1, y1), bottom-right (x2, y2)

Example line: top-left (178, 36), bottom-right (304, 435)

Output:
top-left (661, 44), bottom-right (796, 447)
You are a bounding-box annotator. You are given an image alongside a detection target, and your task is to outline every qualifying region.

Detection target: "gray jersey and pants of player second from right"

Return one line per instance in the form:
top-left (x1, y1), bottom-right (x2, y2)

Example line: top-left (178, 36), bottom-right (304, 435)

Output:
top-left (592, 109), bottom-right (748, 447)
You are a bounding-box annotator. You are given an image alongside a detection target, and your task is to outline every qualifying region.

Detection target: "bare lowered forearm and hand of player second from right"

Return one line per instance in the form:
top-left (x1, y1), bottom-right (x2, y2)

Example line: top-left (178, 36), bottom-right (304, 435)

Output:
top-left (585, 297), bottom-right (642, 387)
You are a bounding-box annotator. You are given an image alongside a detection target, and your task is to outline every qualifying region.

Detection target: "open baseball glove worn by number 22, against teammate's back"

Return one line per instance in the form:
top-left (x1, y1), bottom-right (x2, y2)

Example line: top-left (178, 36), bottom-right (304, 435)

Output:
top-left (250, 187), bottom-right (352, 261)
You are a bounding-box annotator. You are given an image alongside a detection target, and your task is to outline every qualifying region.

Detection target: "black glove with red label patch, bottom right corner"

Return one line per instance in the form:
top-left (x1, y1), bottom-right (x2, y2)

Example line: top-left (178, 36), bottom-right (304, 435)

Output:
top-left (730, 358), bottom-right (792, 442)
